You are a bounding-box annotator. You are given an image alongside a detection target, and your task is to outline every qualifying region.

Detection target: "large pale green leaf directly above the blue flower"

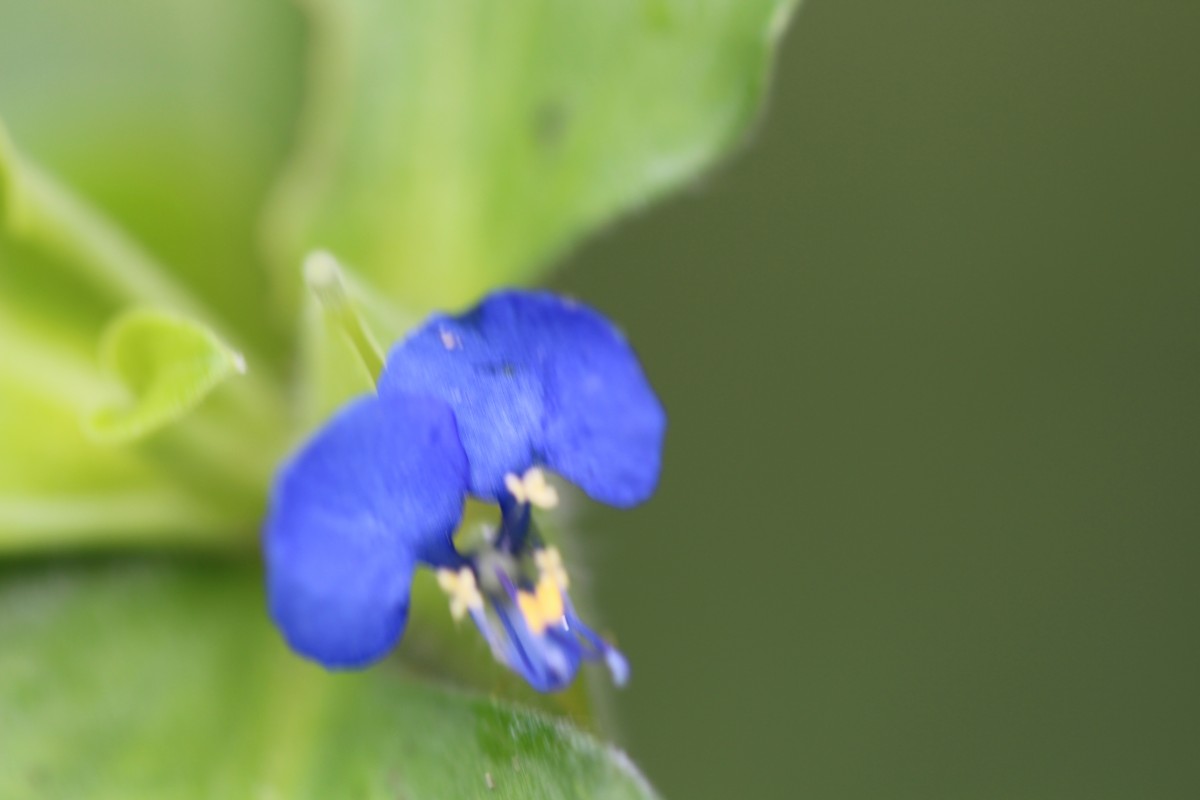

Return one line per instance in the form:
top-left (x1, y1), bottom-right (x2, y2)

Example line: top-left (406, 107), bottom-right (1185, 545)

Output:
top-left (266, 0), bottom-right (796, 311)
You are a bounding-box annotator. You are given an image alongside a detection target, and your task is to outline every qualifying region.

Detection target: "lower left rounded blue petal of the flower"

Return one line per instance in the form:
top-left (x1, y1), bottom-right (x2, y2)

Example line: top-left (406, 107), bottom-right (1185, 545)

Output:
top-left (265, 396), bottom-right (467, 668)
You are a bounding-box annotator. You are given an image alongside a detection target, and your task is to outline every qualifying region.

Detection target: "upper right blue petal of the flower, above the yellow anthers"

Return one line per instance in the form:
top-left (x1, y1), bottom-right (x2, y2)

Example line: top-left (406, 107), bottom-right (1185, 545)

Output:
top-left (379, 290), bottom-right (666, 506)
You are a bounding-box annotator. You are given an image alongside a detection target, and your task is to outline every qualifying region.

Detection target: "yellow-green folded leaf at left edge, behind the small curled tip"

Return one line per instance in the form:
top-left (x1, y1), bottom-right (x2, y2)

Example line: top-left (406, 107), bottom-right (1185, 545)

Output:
top-left (0, 126), bottom-right (287, 552)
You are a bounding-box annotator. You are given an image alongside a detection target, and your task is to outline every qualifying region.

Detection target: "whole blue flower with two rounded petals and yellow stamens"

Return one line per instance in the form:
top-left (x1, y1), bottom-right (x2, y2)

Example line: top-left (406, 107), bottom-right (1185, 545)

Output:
top-left (265, 290), bottom-right (666, 692)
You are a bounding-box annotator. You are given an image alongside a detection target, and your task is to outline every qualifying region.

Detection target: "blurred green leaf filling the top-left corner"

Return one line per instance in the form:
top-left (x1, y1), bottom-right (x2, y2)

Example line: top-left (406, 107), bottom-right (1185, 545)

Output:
top-left (0, 0), bottom-right (304, 355)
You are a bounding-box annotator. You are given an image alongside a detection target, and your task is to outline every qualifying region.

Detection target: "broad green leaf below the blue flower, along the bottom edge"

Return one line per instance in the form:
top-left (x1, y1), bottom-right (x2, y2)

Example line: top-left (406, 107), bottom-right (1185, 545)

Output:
top-left (0, 561), bottom-right (655, 800)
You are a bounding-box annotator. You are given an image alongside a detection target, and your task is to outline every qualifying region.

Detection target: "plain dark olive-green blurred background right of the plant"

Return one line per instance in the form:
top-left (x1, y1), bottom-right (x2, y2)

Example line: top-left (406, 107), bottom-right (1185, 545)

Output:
top-left (557, 0), bottom-right (1200, 800)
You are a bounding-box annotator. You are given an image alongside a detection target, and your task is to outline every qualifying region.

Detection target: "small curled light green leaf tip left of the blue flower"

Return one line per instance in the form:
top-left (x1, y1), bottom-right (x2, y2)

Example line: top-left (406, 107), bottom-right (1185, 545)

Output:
top-left (85, 309), bottom-right (246, 444)
